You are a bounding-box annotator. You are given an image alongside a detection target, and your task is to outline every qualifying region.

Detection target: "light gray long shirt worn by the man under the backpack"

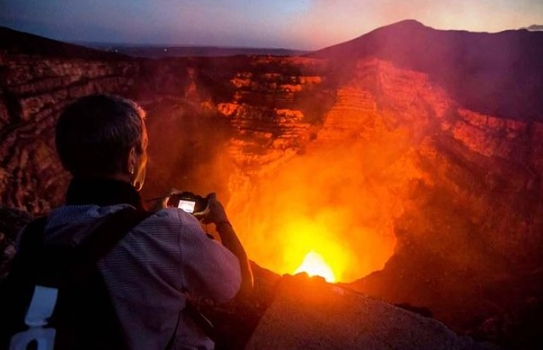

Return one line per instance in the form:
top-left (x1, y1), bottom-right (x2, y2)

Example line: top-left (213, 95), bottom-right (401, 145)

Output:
top-left (45, 204), bottom-right (241, 350)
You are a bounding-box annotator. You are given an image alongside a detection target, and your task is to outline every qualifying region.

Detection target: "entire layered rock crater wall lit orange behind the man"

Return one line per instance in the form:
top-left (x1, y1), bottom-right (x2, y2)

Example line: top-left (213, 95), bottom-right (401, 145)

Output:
top-left (0, 28), bottom-right (543, 348)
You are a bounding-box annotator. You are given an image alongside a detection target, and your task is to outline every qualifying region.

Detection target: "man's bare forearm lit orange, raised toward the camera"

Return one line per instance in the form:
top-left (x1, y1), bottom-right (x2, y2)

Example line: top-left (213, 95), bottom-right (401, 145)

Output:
top-left (205, 193), bottom-right (253, 296)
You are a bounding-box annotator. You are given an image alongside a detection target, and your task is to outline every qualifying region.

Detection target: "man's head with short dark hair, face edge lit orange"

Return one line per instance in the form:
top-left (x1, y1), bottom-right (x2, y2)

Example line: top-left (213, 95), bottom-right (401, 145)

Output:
top-left (55, 95), bottom-right (148, 189)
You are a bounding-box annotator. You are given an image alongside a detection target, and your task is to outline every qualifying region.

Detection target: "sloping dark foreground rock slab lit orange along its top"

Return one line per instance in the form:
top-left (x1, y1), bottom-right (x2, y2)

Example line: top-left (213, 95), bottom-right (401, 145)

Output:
top-left (246, 276), bottom-right (485, 350)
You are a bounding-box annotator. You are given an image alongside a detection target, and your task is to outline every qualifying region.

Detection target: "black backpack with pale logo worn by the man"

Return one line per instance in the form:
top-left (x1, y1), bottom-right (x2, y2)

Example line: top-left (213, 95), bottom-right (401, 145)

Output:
top-left (0, 208), bottom-right (151, 350)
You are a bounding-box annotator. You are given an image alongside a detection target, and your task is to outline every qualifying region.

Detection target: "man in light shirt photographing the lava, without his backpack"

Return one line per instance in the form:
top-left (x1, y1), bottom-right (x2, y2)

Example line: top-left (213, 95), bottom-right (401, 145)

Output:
top-left (45, 95), bottom-right (253, 349)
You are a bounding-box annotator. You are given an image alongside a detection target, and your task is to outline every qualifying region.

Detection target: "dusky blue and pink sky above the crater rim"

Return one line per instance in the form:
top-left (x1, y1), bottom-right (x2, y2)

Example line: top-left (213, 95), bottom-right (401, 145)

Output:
top-left (0, 0), bottom-right (543, 50)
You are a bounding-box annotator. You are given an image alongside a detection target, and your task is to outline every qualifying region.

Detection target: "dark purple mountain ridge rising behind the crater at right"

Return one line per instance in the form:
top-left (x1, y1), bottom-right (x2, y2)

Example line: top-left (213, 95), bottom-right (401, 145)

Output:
top-left (309, 20), bottom-right (543, 120)
